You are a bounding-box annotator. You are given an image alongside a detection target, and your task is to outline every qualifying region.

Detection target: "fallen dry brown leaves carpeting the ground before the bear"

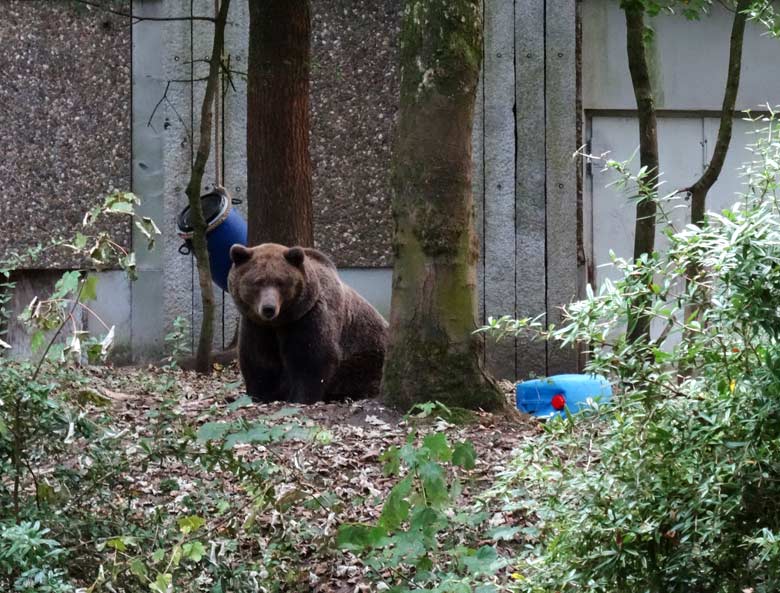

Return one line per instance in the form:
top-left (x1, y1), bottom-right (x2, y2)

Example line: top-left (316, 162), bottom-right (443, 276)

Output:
top-left (74, 367), bottom-right (540, 593)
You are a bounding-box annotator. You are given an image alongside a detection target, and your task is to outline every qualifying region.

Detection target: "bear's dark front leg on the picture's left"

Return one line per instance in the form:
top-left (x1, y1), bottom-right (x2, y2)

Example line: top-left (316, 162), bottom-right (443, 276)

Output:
top-left (238, 319), bottom-right (289, 403)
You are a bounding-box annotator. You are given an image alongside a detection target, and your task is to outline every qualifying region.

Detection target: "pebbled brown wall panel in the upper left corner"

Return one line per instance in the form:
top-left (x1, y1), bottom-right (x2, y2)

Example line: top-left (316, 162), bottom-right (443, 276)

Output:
top-left (0, 0), bottom-right (131, 269)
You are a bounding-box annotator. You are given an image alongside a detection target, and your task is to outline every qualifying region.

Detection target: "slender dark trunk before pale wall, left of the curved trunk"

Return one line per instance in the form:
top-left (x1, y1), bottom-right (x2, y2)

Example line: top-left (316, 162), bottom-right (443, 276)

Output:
top-left (622, 0), bottom-right (660, 341)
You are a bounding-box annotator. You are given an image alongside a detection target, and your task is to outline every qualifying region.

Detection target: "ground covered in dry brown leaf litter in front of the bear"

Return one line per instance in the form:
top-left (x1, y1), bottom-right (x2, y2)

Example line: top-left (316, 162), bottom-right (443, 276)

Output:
top-left (76, 366), bottom-right (541, 593)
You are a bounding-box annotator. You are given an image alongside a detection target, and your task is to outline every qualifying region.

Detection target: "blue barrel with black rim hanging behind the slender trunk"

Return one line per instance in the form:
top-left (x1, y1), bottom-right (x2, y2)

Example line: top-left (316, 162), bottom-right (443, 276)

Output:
top-left (176, 188), bottom-right (247, 290)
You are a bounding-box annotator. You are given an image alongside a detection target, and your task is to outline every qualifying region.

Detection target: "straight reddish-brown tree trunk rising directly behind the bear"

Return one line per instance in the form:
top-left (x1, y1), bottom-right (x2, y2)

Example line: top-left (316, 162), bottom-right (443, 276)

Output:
top-left (247, 0), bottom-right (314, 247)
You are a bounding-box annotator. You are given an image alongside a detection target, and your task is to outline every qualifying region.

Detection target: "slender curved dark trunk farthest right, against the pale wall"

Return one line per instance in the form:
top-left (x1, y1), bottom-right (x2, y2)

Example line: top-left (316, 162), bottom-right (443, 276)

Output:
top-left (688, 0), bottom-right (751, 224)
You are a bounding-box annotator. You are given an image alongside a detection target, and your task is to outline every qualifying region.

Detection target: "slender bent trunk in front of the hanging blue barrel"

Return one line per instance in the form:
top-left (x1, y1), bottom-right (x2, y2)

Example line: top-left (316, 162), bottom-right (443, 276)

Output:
top-left (186, 0), bottom-right (230, 373)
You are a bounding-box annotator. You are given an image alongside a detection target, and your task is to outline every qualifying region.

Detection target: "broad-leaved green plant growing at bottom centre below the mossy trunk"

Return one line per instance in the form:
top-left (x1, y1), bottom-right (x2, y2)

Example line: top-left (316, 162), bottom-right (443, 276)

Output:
top-left (337, 433), bottom-right (505, 593)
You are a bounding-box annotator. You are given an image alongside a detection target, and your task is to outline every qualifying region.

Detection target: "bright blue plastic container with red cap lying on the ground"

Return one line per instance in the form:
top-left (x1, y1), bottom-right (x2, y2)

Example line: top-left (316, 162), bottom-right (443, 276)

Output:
top-left (516, 375), bottom-right (612, 418)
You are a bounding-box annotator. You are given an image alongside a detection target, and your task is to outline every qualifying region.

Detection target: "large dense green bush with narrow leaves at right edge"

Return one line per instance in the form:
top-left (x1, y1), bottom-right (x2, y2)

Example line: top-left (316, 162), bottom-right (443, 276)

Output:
top-left (484, 117), bottom-right (780, 593)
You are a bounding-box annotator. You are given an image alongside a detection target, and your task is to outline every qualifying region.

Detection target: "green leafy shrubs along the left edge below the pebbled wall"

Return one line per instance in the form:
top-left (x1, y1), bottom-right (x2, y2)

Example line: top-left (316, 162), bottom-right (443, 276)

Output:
top-left (0, 192), bottom-right (159, 593)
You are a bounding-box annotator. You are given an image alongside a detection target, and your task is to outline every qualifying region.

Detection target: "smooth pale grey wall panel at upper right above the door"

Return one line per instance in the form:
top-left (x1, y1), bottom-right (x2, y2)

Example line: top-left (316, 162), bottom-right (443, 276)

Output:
top-left (582, 0), bottom-right (780, 111)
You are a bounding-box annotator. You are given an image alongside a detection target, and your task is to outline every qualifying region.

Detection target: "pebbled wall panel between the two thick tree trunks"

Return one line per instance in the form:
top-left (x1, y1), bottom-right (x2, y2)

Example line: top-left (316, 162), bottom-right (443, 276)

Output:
top-left (311, 0), bottom-right (401, 267)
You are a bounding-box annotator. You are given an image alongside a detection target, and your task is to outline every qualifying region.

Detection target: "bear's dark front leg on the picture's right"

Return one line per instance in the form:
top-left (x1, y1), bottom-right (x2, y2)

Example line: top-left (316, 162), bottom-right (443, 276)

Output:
top-left (278, 306), bottom-right (340, 404)
